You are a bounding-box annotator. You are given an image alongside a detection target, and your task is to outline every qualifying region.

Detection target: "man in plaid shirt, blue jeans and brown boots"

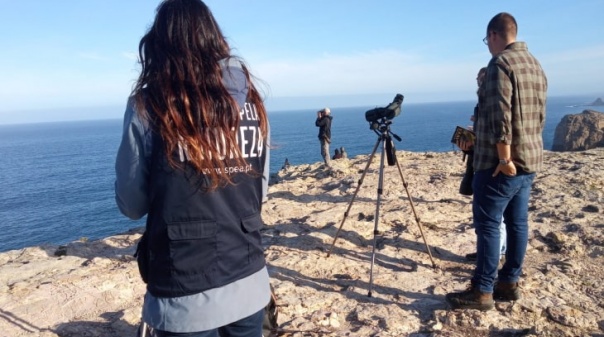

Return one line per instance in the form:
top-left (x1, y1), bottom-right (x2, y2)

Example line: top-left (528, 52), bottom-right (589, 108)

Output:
top-left (446, 13), bottom-right (547, 310)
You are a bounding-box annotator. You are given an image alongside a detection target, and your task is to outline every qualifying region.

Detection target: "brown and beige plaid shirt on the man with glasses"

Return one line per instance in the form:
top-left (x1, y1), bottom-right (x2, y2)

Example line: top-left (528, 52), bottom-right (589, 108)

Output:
top-left (474, 42), bottom-right (547, 172)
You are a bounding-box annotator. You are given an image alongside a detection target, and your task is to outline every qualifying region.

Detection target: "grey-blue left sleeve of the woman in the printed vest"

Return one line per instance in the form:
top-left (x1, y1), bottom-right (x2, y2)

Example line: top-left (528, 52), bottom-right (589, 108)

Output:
top-left (115, 98), bottom-right (151, 220)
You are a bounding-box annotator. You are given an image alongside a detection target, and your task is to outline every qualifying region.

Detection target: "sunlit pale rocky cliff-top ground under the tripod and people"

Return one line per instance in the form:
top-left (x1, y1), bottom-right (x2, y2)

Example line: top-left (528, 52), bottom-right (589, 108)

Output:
top-left (0, 149), bottom-right (604, 337)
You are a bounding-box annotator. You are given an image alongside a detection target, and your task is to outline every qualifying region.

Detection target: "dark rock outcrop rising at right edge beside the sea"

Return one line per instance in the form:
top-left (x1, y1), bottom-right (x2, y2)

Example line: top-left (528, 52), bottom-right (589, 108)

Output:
top-left (552, 110), bottom-right (604, 151)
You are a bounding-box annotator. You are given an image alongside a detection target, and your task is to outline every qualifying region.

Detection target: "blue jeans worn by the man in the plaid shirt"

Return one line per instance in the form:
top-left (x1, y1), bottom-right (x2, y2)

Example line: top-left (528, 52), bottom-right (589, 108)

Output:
top-left (472, 168), bottom-right (535, 293)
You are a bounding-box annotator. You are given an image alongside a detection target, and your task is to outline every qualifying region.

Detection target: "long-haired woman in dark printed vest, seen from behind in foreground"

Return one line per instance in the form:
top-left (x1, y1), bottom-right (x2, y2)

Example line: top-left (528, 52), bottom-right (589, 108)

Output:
top-left (115, 0), bottom-right (270, 337)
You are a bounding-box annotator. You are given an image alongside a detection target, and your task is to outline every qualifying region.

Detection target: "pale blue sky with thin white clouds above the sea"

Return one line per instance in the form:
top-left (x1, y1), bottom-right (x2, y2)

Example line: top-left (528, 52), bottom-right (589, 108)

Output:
top-left (0, 0), bottom-right (604, 124)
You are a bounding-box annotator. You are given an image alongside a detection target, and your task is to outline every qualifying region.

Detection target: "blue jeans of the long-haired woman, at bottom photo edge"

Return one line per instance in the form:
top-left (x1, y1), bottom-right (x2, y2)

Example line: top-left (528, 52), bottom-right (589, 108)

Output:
top-left (151, 308), bottom-right (264, 337)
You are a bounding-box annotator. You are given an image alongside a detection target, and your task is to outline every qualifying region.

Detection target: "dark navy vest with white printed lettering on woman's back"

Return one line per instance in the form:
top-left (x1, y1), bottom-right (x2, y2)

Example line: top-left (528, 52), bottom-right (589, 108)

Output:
top-left (145, 59), bottom-right (266, 297)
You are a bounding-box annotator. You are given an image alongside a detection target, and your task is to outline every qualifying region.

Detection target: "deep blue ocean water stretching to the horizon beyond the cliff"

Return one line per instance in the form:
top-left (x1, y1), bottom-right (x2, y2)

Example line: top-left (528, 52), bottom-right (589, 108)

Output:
top-left (0, 97), bottom-right (598, 252)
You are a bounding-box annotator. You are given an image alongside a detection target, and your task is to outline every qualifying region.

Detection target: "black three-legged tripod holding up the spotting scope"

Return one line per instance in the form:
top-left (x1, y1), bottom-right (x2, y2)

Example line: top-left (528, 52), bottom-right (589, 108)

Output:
top-left (327, 118), bottom-right (436, 297)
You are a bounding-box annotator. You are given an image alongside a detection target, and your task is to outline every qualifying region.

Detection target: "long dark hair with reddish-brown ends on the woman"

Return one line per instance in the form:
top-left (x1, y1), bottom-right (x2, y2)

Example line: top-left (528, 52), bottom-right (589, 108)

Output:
top-left (132, 0), bottom-right (268, 190)
